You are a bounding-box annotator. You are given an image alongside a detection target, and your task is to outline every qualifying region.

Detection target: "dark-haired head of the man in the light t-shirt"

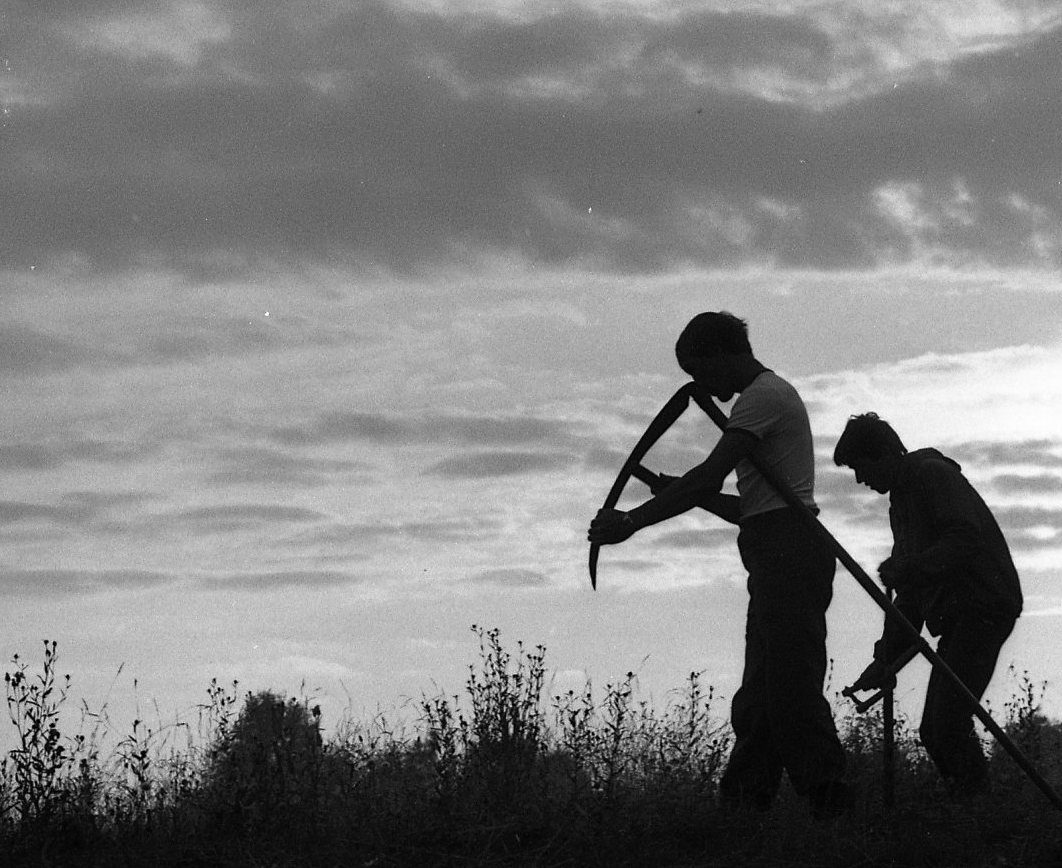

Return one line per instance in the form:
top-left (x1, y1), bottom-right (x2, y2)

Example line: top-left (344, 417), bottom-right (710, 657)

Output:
top-left (674, 311), bottom-right (752, 401)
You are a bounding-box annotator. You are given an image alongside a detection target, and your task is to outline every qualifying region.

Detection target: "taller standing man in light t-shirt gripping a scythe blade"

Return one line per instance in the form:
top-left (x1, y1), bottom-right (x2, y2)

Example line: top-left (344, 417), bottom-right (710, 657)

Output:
top-left (589, 312), bottom-right (847, 815)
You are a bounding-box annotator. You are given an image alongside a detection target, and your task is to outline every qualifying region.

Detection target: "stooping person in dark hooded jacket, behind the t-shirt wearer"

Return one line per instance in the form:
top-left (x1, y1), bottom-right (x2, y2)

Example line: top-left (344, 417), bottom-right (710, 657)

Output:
top-left (834, 413), bottom-right (1022, 795)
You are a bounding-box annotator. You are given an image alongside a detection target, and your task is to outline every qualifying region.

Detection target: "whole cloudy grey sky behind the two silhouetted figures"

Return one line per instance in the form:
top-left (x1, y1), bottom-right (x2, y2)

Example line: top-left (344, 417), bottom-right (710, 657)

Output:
top-left (0, 0), bottom-right (1062, 743)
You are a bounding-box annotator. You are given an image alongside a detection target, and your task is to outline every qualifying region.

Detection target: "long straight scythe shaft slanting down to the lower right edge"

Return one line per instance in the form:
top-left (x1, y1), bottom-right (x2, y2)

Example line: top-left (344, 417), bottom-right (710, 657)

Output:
top-left (691, 387), bottom-right (1062, 810)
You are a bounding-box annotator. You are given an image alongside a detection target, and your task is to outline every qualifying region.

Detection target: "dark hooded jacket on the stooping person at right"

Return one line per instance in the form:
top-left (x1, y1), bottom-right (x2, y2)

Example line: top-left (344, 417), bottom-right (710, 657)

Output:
top-left (874, 448), bottom-right (1022, 662)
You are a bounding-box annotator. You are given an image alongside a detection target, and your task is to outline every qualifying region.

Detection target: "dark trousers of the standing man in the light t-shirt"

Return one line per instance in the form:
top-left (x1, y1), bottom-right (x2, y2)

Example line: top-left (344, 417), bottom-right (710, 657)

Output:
top-left (720, 509), bottom-right (844, 807)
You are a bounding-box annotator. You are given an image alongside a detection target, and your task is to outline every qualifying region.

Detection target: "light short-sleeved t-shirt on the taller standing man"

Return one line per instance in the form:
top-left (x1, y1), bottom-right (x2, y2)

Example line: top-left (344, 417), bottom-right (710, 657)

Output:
top-left (726, 371), bottom-right (816, 518)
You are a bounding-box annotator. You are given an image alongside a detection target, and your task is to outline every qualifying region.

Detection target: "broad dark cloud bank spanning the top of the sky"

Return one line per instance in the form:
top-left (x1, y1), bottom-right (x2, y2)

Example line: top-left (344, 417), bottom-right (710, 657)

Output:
top-left (8, 0), bottom-right (1062, 271)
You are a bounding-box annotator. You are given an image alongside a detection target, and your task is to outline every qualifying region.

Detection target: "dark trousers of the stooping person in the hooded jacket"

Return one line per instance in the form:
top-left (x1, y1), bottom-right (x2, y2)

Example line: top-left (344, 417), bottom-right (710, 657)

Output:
top-left (919, 612), bottom-right (1014, 789)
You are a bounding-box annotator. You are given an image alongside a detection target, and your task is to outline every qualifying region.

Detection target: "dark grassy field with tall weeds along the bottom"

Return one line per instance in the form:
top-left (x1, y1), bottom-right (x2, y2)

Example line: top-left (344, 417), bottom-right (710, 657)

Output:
top-left (6, 627), bottom-right (1062, 868)
